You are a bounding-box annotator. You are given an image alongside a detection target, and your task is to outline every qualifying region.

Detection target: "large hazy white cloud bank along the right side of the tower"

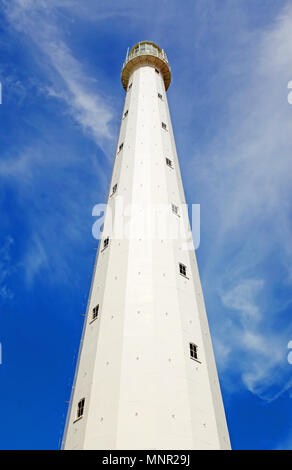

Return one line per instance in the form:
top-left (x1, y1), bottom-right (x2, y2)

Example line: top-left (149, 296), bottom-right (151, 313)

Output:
top-left (187, 5), bottom-right (292, 401)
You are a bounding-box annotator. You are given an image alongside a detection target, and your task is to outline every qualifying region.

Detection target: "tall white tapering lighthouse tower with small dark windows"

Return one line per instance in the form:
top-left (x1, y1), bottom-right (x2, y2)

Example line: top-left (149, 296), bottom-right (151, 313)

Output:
top-left (62, 41), bottom-right (230, 450)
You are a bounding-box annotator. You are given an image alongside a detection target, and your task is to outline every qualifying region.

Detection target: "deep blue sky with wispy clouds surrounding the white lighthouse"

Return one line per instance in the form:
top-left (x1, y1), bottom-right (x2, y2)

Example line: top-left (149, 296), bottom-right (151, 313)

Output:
top-left (0, 0), bottom-right (292, 449)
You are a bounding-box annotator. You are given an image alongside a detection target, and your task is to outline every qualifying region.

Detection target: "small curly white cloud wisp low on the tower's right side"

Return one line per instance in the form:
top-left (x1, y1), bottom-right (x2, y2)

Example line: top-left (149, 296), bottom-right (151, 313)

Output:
top-left (215, 279), bottom-right (292, 402)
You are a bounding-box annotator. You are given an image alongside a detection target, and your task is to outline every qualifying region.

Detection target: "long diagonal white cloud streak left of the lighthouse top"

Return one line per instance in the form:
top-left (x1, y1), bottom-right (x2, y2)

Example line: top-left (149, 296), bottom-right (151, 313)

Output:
top-left (4, 0), bottom-right (113, 148)
